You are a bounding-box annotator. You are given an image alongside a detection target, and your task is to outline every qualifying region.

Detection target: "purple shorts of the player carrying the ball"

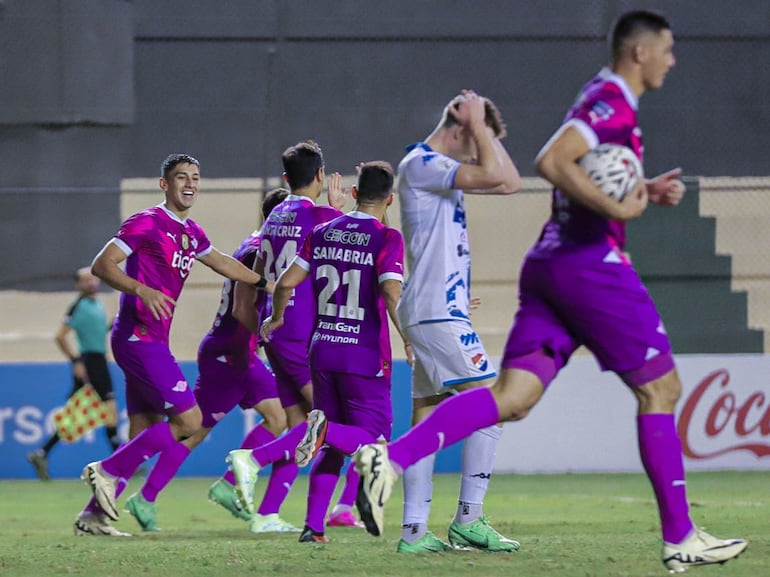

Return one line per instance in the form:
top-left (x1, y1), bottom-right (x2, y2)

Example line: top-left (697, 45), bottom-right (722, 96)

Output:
top-left (502, 252), bottom-right (674, 386)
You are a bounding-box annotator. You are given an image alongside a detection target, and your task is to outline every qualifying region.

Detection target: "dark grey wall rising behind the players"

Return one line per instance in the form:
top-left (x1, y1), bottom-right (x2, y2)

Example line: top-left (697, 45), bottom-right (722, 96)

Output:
top-left (0, 0), bottom-right (770, 290)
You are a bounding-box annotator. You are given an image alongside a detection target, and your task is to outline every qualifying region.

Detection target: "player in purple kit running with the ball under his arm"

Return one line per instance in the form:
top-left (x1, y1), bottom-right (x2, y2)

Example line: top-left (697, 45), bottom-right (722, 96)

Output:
top-left (356, 11), bottom-right (748, 572)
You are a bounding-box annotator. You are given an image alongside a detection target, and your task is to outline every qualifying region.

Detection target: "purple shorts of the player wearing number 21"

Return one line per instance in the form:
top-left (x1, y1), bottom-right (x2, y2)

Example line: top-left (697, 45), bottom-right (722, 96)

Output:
top-left (313, 370), bottom-right (393, 441)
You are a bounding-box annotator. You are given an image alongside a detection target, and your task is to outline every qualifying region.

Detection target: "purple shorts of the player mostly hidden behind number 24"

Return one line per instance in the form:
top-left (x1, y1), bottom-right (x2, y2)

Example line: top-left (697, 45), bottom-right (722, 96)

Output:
top-left (195, 355), bottom-right (278, 429)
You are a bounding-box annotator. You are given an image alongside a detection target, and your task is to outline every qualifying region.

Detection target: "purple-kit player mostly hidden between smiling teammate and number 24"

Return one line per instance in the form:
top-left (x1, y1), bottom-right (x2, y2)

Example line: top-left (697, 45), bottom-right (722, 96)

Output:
top-left (120, 188), bottom-right (299, 532)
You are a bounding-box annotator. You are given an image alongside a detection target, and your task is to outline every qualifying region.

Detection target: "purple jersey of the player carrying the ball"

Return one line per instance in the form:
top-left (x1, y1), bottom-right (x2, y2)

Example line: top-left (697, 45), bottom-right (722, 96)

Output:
top-left (530, 68), bottom-right (643, 258)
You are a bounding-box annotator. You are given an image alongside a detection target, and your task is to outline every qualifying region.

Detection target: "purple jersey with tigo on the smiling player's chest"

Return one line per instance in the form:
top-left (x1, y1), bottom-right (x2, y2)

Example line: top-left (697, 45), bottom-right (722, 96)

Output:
top-left (112, 205), bottom-right (212, 344)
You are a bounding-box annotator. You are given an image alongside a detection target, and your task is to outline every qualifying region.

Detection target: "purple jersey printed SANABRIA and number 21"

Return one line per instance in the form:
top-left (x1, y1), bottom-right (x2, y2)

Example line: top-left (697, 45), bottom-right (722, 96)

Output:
top-left (294, 211), bottom-right (404, 377)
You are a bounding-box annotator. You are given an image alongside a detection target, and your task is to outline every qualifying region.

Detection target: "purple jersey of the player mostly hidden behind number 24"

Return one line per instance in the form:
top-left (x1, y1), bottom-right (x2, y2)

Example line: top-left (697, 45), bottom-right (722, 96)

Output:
top-left (198, 232), bottom-right (260, 368)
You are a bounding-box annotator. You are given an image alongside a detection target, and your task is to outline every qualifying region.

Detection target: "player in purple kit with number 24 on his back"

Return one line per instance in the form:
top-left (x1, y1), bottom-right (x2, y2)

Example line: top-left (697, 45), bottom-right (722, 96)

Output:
top-left (226, 141), bottom-right (355, 512)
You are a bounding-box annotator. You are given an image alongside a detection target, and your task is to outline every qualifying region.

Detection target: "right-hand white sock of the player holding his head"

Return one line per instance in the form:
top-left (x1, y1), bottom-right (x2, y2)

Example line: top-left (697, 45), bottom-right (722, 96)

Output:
top-left (455, 425), bottom-right (503, 523)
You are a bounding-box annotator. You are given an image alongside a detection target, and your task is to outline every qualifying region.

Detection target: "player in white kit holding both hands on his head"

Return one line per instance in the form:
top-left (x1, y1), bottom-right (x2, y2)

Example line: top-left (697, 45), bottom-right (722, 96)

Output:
top-left (384, 90), bottom-right (521, 553)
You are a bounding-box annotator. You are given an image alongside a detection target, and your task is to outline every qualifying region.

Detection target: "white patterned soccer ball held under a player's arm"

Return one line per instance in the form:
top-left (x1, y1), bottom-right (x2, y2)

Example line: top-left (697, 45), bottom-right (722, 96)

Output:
top-left (578, 144), bottom-right (644, 200)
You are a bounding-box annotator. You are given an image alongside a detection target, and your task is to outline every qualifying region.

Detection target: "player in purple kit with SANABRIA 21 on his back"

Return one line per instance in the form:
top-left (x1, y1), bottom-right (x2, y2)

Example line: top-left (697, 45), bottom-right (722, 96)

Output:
top-left (261, 161), bottom-right (411, 542)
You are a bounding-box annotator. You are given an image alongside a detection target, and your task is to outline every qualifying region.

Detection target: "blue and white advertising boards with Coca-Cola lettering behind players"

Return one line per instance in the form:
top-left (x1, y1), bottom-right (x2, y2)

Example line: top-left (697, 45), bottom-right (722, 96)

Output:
top-left (0, 355), bottom-right (770, 478)
